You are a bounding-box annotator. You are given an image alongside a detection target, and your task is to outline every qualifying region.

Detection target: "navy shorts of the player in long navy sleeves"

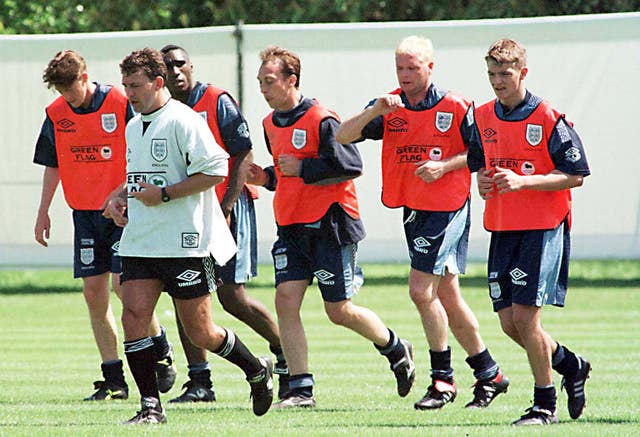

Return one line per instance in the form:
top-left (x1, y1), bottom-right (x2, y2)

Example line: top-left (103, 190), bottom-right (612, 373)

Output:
top-left (271, 223), bottom-right (364, 302)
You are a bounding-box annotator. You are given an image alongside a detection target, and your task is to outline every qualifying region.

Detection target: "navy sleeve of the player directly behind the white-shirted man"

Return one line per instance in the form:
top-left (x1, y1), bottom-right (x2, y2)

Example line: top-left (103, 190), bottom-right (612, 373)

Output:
top-left (217, 94), bottom-right (252, 156)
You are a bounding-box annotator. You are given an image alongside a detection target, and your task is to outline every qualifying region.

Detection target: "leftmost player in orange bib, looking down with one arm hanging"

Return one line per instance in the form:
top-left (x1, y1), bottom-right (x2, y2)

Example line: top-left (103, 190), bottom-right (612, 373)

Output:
top-left (33, 50), bottom-right (175, 401)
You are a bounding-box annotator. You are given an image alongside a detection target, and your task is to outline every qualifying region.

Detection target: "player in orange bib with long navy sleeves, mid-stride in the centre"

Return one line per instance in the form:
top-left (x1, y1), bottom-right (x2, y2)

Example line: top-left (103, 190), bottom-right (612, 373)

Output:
top-left (249, 47), bottom-right (415, 408)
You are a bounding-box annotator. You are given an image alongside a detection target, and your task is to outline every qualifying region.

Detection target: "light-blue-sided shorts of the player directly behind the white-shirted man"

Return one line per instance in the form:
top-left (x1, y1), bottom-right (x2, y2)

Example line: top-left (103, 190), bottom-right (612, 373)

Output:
top-left (215, 188), bottom-right (258, 284)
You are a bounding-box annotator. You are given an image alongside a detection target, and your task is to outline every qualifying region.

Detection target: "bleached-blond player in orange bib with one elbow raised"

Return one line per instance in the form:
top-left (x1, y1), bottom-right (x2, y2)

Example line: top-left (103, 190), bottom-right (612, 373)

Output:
top-left (336, 36), bottom-right (509, 410)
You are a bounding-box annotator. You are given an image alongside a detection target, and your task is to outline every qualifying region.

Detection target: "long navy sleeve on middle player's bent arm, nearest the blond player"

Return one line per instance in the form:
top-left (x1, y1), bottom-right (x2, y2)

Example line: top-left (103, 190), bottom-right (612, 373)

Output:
top-left (300, 117), bottom-right (362, 184)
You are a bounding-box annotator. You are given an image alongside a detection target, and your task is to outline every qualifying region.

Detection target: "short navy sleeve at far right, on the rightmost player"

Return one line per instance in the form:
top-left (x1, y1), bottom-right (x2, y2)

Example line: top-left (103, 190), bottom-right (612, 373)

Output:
top-left (549, 117), bottom-right (591, 176)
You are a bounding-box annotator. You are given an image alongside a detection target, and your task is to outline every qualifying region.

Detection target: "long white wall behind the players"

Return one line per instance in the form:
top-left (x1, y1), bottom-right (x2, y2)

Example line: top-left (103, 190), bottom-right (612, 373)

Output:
top-left (0, 13), bottom-right (640, 266)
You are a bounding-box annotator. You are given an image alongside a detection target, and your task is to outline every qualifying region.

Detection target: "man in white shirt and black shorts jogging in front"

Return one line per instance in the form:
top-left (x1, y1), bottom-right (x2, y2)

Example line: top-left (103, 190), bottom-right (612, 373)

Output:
top-left (108, 48), bottom-right (273, 424)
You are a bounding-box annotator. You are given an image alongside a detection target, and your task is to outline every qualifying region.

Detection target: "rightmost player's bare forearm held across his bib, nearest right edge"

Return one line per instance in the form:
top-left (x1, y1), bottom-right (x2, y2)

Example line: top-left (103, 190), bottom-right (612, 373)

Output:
top-left (493, 167), bottom-right (583, 193)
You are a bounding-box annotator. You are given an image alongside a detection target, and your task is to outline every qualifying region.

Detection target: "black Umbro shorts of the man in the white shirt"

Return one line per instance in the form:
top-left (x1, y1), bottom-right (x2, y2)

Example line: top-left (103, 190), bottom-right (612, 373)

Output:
top-left (120, 256), bottom-right (216, 299)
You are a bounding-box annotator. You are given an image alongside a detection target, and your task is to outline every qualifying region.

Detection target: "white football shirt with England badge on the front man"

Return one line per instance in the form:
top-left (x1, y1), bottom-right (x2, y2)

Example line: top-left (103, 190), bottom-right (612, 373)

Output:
top-left (119, 99), bottom-right (236, 265)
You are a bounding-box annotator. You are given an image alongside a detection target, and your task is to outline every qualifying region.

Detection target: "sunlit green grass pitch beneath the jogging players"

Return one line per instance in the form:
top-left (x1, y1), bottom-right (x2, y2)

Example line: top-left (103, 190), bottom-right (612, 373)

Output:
top-left (0, 261), bottom-right (640, 436)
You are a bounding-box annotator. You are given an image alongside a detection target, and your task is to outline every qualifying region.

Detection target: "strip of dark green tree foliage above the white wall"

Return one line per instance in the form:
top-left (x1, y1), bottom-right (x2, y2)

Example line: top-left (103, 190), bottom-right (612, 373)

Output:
top-left (0, 0), bottom-right (640, 34)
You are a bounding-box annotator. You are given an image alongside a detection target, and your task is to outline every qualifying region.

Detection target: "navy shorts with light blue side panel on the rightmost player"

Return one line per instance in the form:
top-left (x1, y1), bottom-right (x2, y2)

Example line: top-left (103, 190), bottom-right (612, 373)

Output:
top-left (488, 221), bottom-right (571, 311)
